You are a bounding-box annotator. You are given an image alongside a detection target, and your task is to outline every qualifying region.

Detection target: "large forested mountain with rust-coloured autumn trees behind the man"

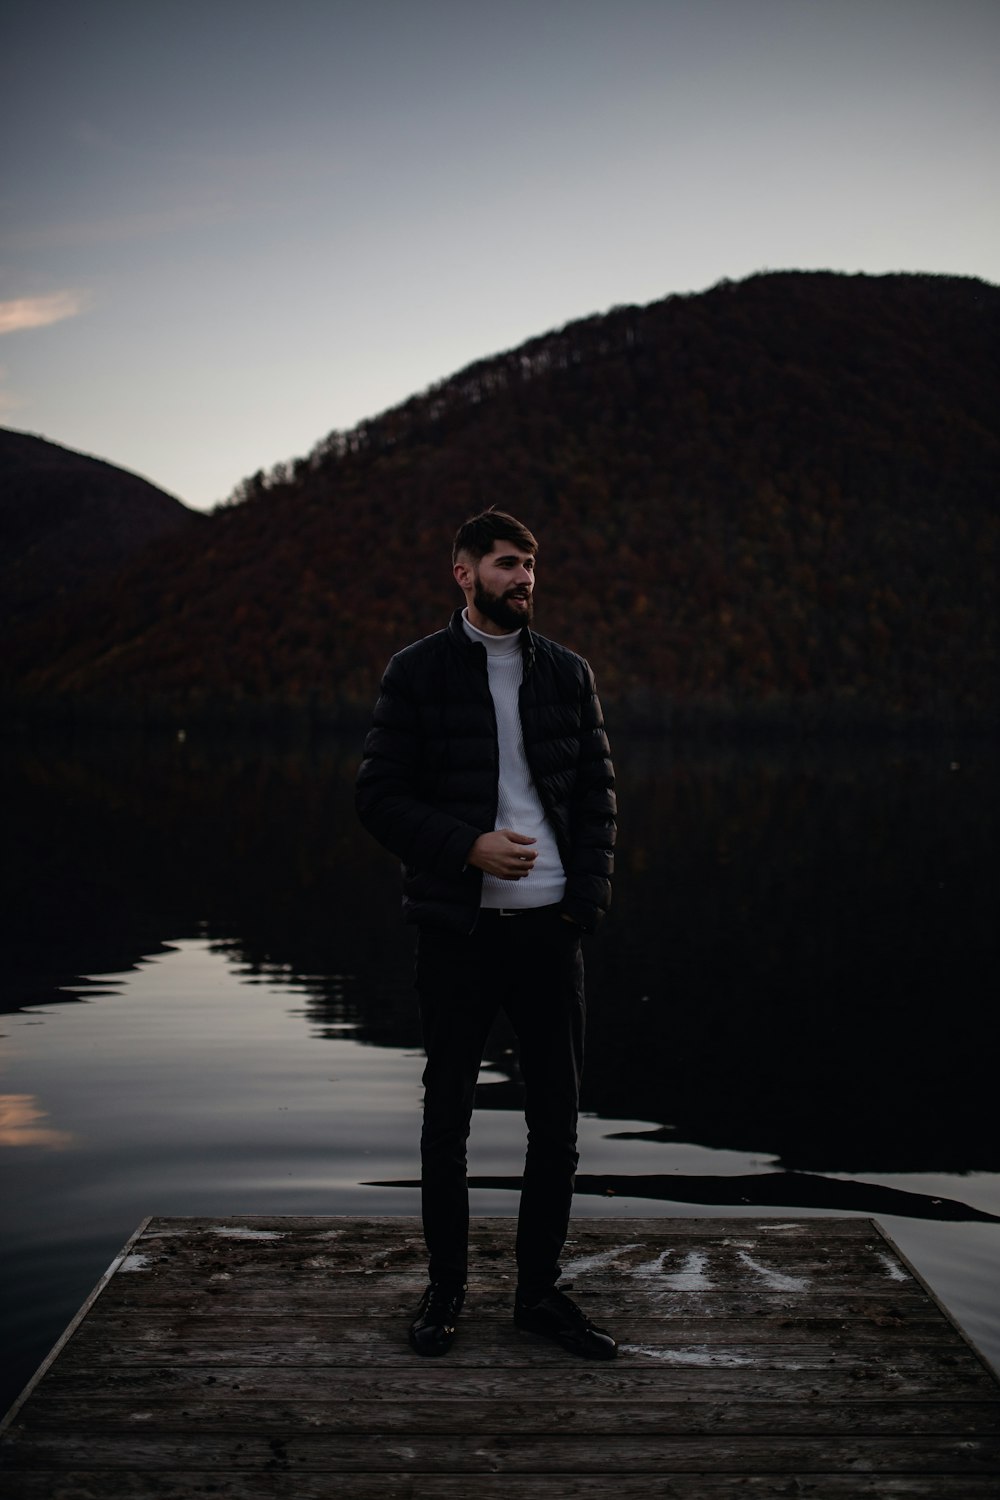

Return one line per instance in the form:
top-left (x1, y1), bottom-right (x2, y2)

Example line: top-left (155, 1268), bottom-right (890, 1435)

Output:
top-left (9, 272), bottom-right (1000, 738)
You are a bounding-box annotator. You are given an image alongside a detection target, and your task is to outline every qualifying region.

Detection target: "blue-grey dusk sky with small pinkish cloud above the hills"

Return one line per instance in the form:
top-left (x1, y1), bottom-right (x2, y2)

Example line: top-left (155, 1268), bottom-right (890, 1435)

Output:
top-left (0, 0), bottom-right (1000, 507)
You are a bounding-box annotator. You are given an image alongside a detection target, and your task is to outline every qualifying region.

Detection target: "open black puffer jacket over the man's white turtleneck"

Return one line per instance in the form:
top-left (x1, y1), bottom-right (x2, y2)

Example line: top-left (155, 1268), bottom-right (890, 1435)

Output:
top-left (357, 611), bottom-right (616, 932)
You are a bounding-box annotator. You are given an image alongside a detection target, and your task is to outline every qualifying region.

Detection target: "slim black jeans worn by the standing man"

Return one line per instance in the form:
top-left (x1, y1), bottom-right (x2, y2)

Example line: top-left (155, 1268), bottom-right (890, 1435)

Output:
top-left (417, 908), bottom-right (585, 1296)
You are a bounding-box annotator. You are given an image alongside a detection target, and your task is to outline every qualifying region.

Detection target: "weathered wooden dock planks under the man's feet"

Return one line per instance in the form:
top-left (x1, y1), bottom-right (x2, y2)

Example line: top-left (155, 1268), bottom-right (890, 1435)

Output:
top-left (0, 1218), bottom-right (1000, 1500)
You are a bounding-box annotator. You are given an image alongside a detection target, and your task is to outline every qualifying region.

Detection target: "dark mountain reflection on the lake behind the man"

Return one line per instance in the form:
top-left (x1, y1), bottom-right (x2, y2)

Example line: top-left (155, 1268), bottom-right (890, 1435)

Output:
top-left (3, 737), bottom-right (1000, 1173)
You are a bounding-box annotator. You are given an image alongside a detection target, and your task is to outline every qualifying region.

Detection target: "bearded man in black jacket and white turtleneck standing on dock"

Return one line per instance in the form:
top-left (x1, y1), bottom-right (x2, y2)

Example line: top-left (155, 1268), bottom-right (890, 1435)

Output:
top-left (357, 510), bottom-right (618, 1359)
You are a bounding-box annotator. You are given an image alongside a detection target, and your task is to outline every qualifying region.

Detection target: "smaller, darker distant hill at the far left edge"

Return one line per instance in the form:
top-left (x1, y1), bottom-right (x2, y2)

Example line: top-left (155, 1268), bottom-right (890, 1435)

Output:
top-left (0, 428), bottom-right (199, 629)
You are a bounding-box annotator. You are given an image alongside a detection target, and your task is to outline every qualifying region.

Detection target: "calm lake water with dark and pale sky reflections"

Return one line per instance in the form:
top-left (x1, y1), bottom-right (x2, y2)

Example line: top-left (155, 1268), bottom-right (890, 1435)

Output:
top-left (0, 734), bottom-right (1000, 1409)
